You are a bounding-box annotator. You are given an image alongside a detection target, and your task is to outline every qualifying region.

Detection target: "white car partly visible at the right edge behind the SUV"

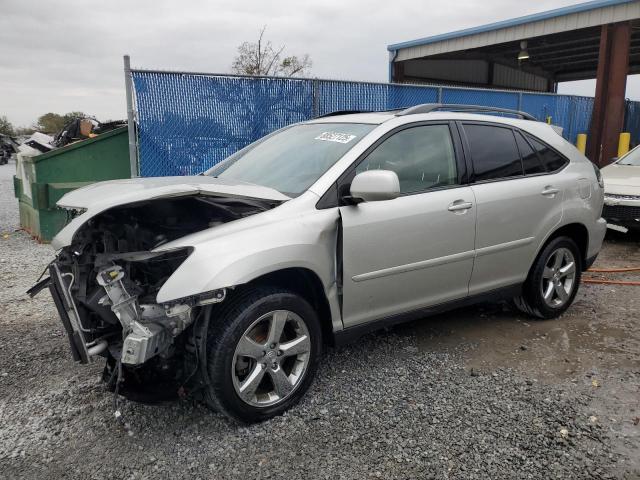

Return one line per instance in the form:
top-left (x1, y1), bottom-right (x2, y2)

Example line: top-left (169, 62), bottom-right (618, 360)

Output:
top-left (602, 146), bottom-right (640, 232)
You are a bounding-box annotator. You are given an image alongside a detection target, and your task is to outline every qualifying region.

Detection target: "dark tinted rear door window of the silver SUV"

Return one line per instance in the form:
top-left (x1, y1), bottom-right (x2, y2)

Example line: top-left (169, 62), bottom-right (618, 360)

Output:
top-left (464, 124), bottom-right (523, 181)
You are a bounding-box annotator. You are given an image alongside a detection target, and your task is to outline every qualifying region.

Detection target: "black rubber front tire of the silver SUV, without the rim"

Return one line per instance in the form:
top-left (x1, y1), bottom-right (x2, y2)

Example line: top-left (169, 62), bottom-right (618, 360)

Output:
top-left (205, 287), bottom-right (322, 423)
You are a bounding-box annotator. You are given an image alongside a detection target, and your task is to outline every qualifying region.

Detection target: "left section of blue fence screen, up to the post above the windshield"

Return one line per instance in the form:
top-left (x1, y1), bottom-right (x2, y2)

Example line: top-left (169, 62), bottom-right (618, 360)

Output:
top-left (133, 72), bottom-right (313, 177)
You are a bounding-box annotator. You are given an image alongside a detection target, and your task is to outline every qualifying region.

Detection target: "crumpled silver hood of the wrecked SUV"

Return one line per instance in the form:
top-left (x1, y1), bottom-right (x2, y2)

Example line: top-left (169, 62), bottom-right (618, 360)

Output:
top-left (51, 175), bottom-right (290, 250)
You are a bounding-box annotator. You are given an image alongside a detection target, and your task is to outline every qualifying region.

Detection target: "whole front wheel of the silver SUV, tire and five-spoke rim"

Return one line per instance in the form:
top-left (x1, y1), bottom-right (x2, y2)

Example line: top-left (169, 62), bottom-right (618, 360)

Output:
top-left (206, 288), bottom-right (321, 422)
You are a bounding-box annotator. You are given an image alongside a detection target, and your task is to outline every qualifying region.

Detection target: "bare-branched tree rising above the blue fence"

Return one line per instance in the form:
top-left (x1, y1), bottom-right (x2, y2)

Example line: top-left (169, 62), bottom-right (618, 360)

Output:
top-left (231, 26), bottom-right (312, 77)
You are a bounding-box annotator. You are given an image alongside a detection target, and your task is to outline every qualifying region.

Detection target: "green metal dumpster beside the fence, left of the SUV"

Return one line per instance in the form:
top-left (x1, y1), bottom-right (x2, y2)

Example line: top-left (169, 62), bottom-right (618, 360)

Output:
top-left (13, 127), bottom-right (131, 242)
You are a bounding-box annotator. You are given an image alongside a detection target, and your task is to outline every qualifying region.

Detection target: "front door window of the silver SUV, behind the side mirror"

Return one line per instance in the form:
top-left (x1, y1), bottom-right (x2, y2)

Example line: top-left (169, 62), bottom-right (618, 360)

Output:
top-left (356, 125), bottom-right (458, 193)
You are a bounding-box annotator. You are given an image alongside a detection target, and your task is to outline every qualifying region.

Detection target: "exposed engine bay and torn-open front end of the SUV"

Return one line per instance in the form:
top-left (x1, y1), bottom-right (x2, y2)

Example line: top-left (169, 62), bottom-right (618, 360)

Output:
top-left (30, 195), bottom-right (281, 402)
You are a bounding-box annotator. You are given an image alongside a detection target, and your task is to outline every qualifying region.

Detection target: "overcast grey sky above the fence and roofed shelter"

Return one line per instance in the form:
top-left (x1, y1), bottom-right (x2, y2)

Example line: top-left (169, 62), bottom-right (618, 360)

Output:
top-left (0, 0), bottom-right (640, 126)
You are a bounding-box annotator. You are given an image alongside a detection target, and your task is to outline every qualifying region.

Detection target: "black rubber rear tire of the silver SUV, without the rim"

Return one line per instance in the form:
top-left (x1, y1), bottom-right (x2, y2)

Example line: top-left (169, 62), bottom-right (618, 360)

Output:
top-left (513, 236), bottom-right (582, 319)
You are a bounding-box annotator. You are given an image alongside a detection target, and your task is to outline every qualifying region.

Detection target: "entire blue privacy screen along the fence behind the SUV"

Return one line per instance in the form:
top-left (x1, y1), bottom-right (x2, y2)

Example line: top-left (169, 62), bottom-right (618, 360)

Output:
top-left (132, 70), bottom-right (640, 177)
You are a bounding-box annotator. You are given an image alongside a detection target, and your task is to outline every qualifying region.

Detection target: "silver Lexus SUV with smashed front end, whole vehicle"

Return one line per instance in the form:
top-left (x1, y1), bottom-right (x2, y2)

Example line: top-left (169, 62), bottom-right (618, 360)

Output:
top-left (31, 105), bottom-right (606, 422)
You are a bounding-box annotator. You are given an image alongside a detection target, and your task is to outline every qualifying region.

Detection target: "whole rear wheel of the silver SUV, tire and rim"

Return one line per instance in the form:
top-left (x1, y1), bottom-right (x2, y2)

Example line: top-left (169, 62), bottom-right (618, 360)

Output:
top-left (514, 237), bottom-right (582, 319)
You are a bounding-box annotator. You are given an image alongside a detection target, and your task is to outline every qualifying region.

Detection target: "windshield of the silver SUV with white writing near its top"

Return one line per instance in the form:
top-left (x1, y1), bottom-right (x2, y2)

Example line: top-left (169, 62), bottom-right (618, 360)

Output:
top-left (205, 123), bottom-right (376, 197)
